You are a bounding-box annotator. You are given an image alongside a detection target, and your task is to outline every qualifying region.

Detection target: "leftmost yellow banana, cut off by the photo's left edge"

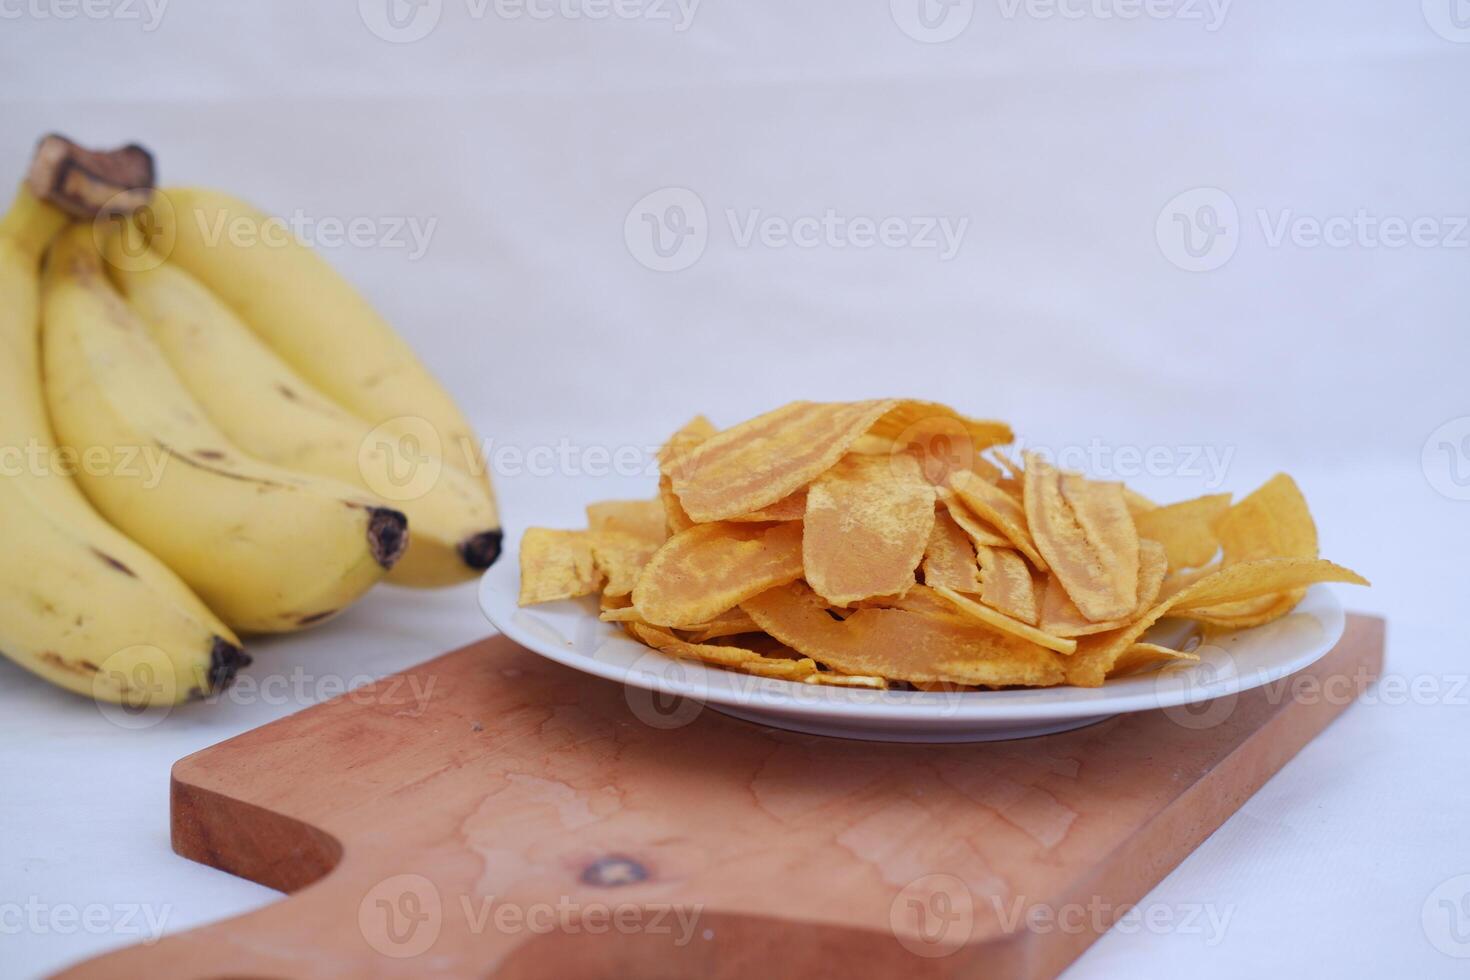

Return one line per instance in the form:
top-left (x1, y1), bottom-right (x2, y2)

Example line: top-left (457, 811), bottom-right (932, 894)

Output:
top-left (0, 188), bottom-right (250, 707)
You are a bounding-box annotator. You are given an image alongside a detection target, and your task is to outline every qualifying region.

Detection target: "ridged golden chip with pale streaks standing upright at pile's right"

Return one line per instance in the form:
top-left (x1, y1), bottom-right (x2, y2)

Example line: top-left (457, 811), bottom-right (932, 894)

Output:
top-left (1025, 453), bottom-right (1139, 623)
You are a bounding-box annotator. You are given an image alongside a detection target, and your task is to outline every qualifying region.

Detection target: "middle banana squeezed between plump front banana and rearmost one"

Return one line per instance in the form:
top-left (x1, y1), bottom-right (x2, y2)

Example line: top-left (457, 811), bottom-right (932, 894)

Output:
top-left (107, 229), bottom-right (501, 586)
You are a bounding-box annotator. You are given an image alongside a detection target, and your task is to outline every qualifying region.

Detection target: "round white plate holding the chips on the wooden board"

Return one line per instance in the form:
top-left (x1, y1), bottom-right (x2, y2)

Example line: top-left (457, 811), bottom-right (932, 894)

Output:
top-left (479, 551), bottom-right (1345, 742)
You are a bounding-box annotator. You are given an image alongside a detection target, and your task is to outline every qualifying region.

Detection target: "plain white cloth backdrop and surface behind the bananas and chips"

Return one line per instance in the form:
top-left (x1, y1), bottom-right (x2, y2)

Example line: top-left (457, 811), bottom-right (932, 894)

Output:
top-left (0, 0), bottom-right (1470, 977)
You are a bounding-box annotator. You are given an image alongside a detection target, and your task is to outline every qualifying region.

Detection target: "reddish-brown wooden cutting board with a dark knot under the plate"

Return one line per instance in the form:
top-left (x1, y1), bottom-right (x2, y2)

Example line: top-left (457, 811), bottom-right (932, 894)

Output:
top-left (65, 616), bottom-right (1383, 979)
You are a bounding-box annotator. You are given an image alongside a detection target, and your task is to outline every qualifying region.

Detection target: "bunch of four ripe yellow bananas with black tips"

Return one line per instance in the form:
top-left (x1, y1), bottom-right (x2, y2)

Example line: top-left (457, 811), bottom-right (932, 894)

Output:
top-left (0, 145), bottom-right (501, 707)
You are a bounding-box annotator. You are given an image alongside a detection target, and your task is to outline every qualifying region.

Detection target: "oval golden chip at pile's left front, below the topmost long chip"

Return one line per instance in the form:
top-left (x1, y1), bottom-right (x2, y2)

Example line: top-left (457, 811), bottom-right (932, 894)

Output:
top-left (634, 522), bottom-right (801, 626)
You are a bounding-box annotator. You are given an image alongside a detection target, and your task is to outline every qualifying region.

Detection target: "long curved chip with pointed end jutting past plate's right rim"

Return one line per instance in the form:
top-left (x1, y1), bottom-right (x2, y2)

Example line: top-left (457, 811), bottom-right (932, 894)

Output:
top-left (1067, 558), bottom-right (1367, 688)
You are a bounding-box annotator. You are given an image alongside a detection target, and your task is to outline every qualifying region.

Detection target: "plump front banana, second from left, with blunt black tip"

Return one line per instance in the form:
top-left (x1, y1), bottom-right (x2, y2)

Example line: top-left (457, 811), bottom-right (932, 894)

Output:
top-left (41, 225), bottom-right (407, 632)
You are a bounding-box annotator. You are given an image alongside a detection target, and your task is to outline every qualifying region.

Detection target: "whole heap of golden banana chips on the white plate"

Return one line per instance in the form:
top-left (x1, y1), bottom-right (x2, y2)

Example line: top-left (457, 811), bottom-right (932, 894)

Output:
top-left (520, 400), bottom-right (1367, 691)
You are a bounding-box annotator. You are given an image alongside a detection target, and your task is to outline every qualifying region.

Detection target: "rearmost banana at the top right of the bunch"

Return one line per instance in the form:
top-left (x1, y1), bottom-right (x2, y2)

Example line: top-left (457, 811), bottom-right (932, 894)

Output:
top-left (153, 187), bottom-right (491, 494)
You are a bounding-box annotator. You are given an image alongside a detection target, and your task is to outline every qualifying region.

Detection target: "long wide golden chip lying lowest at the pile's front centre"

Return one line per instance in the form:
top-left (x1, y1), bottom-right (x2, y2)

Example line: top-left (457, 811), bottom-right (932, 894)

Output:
top-left (742, 582), bottom-right (1063, 688)
